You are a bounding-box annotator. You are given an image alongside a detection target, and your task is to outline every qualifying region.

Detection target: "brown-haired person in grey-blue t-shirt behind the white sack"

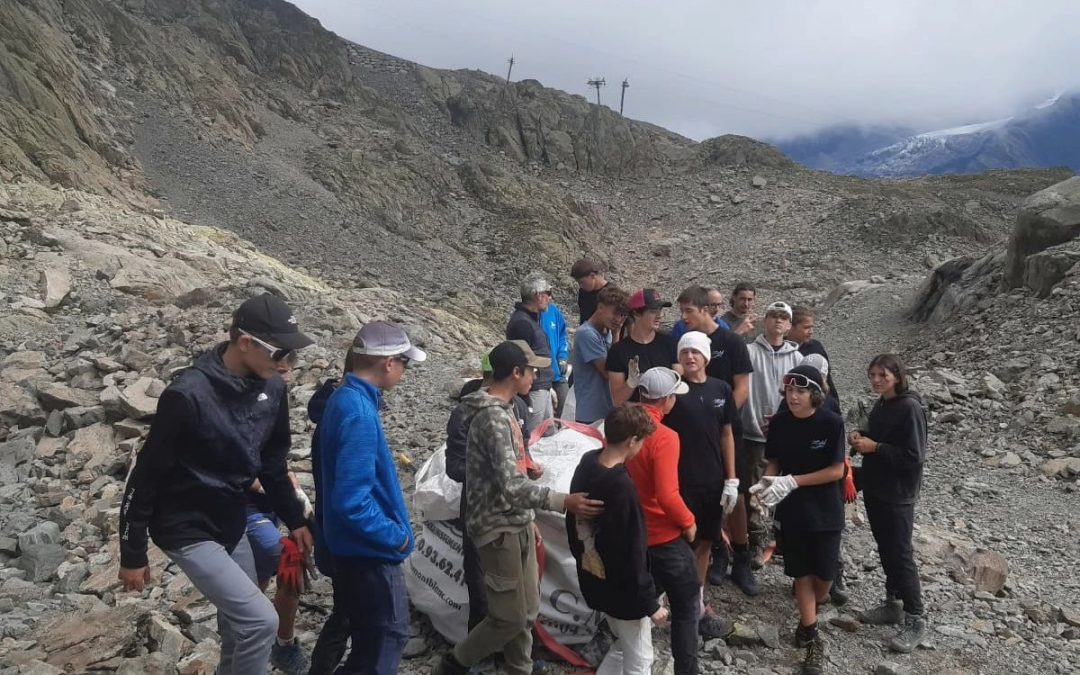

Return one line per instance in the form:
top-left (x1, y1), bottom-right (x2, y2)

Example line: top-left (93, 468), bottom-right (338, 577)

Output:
top-left (570, 284), bottom-right (627, 424)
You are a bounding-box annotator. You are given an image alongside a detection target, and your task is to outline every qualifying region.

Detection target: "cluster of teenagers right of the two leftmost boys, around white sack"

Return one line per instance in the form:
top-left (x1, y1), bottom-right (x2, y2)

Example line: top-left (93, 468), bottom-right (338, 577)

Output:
top-left (436, 258), bottom-right (927, 675)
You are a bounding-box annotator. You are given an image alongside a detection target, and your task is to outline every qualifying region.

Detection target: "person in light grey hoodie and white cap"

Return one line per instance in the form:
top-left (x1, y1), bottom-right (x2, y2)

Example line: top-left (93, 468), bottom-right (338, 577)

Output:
top-left (730, 302), bottom-right (805, 579)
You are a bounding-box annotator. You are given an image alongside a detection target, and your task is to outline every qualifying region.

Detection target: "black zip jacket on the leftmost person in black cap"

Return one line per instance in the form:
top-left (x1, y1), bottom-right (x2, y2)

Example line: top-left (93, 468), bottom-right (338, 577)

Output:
top-left (120, 343), bottom-right (305, 569)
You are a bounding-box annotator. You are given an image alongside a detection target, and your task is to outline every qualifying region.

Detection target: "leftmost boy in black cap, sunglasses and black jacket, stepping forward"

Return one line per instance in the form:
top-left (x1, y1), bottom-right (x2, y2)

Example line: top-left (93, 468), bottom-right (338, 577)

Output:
top-left (119, 294), bottom-right (312, 675)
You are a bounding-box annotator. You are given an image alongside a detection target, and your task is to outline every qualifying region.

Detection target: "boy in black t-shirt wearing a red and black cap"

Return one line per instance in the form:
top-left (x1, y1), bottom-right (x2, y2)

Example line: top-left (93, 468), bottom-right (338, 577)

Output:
top-left (604, 288), bottom-right (678, 405)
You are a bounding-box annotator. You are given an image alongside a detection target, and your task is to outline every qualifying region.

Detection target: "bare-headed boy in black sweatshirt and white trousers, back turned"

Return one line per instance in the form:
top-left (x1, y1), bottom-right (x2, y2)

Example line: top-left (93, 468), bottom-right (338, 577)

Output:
top-left (566, 404), bottom-right (667, 673)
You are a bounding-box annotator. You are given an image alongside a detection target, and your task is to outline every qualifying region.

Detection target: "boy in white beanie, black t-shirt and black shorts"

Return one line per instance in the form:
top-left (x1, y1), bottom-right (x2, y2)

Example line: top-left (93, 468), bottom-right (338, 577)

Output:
top-left (664, 330), bottom-right (739, 638)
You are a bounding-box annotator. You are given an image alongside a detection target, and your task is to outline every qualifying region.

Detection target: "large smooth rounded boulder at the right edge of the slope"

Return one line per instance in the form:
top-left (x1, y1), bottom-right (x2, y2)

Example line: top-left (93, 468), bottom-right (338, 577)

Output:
top-left (1001, 176), bottom-right (1080, 291)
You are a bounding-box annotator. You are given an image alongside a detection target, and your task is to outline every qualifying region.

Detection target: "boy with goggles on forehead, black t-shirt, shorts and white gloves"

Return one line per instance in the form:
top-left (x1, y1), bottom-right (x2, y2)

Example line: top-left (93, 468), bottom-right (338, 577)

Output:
top-left (751, 365), bottom-right (845, 675)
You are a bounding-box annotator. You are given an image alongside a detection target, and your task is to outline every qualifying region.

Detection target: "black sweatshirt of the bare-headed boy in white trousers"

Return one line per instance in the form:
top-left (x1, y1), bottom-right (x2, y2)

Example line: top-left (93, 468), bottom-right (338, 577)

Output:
top-left (566, 450), bottom-right (660, 621)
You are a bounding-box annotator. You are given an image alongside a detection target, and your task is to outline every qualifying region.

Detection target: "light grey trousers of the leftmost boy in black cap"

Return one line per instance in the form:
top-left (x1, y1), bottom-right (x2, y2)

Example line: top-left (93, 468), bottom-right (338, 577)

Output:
top-left (165, 537), bottom-right (278, 675)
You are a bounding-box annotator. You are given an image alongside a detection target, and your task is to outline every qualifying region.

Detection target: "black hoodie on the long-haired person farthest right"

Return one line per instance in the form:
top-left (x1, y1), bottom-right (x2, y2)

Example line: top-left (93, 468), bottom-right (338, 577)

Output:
top-left (860, 390), bottom-right (927, 504)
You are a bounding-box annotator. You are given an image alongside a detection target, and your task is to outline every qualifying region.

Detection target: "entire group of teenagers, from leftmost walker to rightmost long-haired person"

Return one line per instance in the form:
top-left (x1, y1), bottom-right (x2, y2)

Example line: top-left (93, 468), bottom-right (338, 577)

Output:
top-left (107, 253), bottom-right (926, 675)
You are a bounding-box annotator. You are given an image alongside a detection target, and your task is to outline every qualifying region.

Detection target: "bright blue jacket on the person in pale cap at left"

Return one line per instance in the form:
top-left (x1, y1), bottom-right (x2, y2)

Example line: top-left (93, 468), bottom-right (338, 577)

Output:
top-left (319, 374), bottom-right (414, 563)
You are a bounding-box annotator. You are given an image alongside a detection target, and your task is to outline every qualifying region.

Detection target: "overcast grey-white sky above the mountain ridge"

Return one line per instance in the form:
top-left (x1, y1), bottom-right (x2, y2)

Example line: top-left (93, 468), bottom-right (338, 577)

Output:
top-left (293, 0), bottom-right (1080, 139)
